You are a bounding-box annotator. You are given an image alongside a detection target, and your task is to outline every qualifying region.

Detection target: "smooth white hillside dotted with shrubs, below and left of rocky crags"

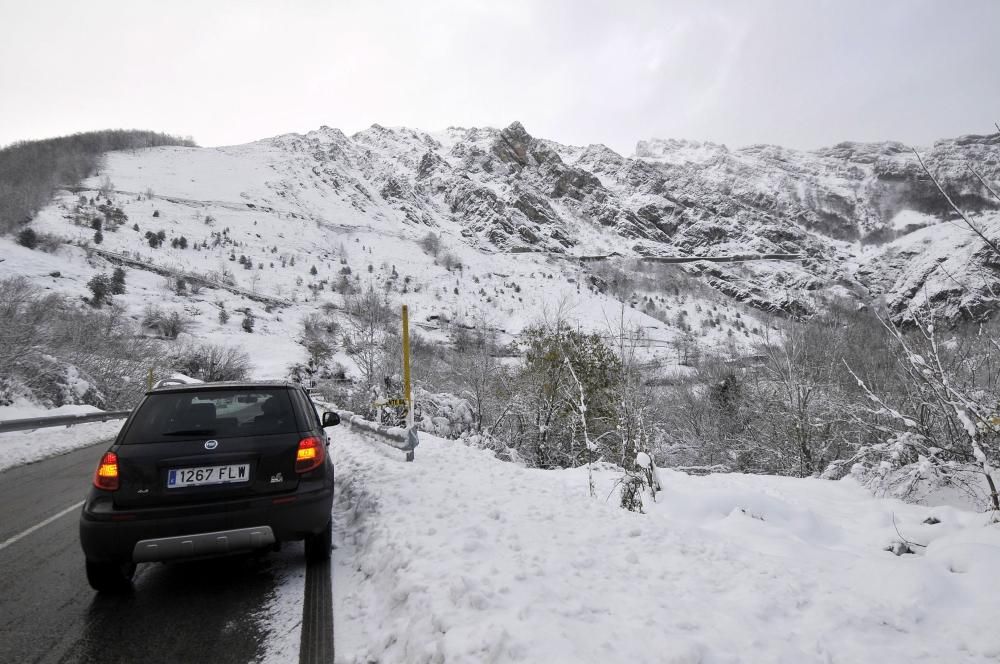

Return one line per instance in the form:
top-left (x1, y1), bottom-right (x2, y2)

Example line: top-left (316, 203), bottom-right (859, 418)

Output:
top-left (0, 127), bottom-right (784, 394)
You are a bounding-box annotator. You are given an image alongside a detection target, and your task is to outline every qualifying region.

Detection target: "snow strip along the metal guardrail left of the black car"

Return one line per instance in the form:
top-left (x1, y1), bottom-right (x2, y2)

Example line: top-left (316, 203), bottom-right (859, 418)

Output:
top-left (0, 401), bottom-right (122, 470)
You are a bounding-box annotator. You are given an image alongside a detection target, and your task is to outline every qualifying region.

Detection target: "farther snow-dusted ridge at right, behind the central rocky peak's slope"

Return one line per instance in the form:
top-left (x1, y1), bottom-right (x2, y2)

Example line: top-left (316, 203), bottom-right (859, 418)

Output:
top-left (636, 135), bottom-right (1000, 241)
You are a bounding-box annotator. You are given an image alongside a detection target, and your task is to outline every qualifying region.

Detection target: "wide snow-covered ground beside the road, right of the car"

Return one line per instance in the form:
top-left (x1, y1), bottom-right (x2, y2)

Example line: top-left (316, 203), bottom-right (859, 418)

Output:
top-left (332, 431), bottom-right (1000, 663)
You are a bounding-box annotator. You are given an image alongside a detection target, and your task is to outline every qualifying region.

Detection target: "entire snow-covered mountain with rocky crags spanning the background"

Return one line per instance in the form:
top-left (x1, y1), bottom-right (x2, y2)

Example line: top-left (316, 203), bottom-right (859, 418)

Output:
top-left (7, 122), bottom-right (1000, 384)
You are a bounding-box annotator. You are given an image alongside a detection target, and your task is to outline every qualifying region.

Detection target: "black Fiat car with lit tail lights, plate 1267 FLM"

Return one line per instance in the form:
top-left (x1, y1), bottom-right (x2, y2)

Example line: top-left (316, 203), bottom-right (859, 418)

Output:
top-left (80, 383), bottom-right (340, 591)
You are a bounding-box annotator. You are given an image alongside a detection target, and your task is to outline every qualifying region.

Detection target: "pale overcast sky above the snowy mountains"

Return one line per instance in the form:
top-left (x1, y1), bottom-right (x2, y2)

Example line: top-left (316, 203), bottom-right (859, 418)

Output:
top-left (0, 0), bottom-right (1000, 154)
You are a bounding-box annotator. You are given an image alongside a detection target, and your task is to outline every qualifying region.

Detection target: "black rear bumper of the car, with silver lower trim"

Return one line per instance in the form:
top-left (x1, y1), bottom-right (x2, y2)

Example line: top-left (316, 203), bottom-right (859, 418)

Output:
top-left (80, 488), bottom-right (333, 562)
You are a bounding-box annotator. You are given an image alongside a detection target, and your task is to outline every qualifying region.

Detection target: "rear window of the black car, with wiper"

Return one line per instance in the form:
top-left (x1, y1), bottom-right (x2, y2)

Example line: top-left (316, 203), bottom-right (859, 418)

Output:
top-left (123, 389), bottom-right (298, 445)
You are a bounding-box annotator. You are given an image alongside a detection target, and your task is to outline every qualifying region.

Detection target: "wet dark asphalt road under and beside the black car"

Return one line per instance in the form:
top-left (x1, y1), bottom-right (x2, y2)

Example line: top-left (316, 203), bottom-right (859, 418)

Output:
top-left (0, 442), bottom-right (333, 664)
